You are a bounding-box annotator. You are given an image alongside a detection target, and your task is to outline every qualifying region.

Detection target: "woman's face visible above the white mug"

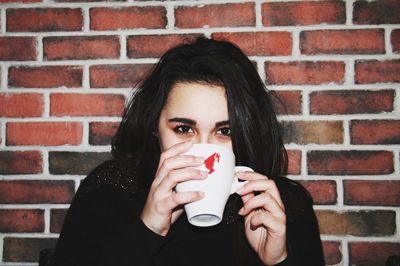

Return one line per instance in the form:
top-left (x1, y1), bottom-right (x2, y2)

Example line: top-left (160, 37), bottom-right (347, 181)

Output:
top-left (158, 83), bottom-right (232, 151)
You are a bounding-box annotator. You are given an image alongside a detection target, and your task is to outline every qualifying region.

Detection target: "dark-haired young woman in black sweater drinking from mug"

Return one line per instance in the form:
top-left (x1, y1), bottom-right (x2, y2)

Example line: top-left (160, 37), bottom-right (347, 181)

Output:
top-left (52, 38), bottom-right (324, 266)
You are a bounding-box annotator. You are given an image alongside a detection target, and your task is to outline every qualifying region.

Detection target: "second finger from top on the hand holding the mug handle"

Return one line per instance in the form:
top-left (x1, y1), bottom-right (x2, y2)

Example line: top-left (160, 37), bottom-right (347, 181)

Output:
top-left (237, 179), bottom-right (284, 208)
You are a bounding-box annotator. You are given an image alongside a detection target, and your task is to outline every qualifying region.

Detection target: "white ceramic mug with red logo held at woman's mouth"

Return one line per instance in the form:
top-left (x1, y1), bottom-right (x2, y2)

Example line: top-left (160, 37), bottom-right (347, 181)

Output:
top-left (175, 144), bottom-right (253, 227)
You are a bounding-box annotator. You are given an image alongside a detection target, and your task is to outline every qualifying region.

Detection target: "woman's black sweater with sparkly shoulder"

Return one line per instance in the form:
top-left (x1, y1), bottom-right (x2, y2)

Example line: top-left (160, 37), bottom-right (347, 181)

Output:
top-left (52, 161), bottom-right (324, 266)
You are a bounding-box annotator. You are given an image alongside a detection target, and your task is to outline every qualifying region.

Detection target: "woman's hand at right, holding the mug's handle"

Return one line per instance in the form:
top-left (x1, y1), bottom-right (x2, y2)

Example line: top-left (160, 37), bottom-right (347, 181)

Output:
top-left (238, 172), bottom-right (287, 265)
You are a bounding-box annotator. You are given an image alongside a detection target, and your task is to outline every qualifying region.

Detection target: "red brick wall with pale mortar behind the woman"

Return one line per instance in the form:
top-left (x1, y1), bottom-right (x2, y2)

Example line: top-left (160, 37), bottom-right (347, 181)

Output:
top-left (0, 0), bottom-right (400, 266)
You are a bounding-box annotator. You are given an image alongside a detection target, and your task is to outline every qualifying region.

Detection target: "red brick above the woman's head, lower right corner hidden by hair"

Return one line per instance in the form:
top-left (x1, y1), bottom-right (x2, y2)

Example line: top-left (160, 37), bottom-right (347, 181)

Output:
top-left (128, 34), bottom-right (202, 58)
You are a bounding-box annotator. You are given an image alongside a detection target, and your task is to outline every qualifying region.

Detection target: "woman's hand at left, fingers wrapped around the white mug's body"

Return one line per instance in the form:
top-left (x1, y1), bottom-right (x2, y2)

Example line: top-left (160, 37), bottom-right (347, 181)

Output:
top-left (141, 141), bottom-right (207, 236)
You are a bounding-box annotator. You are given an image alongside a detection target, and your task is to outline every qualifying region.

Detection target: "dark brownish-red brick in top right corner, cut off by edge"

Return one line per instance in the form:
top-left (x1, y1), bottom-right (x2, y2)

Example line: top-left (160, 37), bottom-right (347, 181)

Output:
top-left (353, 0), bottom-right (400, 24)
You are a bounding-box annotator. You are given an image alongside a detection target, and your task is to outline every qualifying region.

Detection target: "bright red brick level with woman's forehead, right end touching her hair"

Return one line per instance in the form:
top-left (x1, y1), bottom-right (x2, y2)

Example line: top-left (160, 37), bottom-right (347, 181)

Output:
top-left (50, 93), bottom-right (125, 116)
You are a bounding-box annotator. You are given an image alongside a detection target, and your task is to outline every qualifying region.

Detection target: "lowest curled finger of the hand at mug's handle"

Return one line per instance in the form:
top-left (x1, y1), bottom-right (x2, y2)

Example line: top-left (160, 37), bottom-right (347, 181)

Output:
top-left (250, 211), bottom-right (286, 236)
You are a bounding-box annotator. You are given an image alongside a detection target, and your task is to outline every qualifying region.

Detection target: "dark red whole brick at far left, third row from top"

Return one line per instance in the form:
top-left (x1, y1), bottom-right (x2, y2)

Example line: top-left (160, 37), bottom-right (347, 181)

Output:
top-left (8, 66), bottom-right (83, 88)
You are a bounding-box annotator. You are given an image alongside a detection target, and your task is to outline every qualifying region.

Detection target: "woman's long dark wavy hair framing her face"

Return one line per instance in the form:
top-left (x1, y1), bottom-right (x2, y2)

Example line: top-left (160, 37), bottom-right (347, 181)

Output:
top-left (112, 37), bottom-right (287, 189)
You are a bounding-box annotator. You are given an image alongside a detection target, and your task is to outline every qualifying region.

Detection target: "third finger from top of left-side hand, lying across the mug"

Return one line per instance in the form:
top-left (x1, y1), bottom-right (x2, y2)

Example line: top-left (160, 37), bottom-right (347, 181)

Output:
top-left (159, 168), bottom-right (208, 192)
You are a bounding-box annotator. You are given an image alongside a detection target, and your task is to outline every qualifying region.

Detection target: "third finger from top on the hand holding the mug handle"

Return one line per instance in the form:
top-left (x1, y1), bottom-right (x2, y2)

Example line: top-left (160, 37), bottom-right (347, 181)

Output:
top-left (239, 193), bottom-right (286, 218)
